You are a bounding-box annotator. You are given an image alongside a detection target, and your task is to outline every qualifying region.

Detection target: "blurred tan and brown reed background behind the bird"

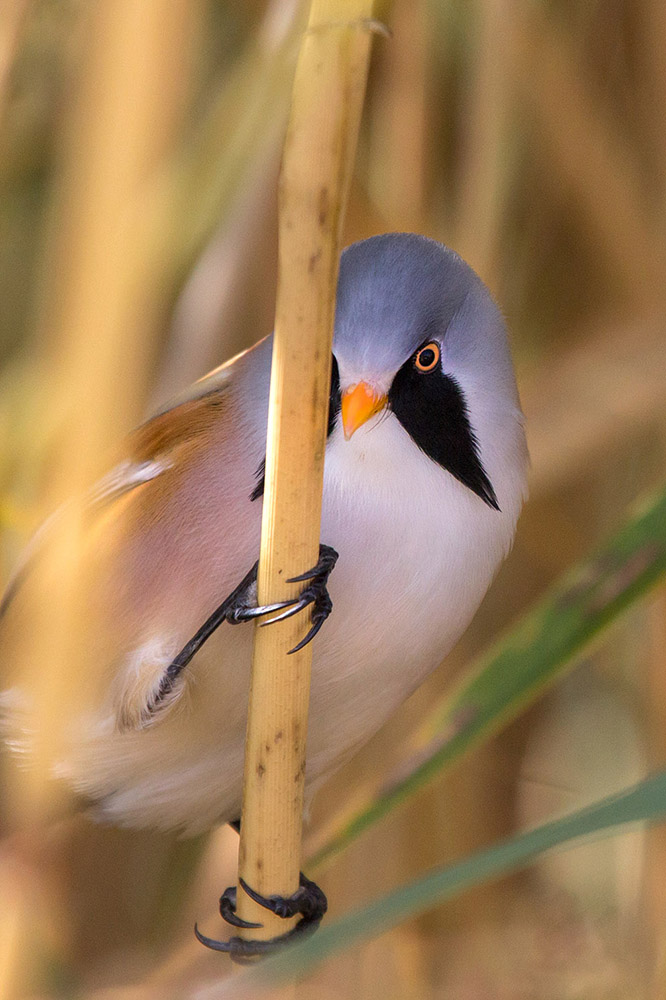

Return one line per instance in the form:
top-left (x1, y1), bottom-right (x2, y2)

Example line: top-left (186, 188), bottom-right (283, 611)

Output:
top-left (0, 0), bottom-right (666, 1000)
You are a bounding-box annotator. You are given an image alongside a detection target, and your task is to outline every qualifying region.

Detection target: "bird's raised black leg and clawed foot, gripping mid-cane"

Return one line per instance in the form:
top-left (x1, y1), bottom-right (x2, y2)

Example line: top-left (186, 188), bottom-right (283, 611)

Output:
top-left (155, 545), bottom-right (338, 705)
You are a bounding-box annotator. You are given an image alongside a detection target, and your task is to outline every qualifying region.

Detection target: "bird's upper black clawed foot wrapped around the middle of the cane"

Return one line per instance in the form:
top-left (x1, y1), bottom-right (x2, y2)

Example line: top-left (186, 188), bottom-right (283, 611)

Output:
top-left (225, 545), bottom-right (338, 653)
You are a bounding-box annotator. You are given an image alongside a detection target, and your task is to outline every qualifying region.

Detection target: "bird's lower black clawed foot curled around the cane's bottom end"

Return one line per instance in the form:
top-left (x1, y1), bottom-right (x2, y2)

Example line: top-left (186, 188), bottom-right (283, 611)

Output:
top-left (194, 872), bottom-right (328, 963)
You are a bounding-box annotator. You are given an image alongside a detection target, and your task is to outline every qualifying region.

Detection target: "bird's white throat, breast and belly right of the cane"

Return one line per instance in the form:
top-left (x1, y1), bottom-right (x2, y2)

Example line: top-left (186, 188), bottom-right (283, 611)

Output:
top-left (308, 415), bottom-right (524, 780)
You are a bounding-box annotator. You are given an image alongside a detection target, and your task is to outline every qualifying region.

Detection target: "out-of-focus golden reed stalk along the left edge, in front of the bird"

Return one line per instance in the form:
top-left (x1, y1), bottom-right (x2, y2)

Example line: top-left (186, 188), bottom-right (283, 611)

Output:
top-left (0, 0), bottom-right (200, 997)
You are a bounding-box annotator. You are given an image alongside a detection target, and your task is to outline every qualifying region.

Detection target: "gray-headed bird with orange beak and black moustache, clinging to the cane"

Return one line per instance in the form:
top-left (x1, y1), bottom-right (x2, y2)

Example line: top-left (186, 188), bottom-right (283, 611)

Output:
top-left (0, 233), bottom-right (529, 948)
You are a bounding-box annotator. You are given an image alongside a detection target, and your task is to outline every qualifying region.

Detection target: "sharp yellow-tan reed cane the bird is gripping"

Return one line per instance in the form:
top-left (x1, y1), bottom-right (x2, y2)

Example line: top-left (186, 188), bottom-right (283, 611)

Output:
top-left (238, 0), bottom-right (373, 938)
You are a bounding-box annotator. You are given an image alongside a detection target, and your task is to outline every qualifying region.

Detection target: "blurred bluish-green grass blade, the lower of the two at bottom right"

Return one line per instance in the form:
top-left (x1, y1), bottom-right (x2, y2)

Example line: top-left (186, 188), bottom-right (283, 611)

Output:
top-left (217, 773), bottom-right (666, 1000)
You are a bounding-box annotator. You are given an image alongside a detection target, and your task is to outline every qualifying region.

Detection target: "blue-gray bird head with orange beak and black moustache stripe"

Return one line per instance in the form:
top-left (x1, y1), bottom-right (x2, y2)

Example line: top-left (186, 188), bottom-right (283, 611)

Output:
top-left (332, 233), bottom-right (522, 507)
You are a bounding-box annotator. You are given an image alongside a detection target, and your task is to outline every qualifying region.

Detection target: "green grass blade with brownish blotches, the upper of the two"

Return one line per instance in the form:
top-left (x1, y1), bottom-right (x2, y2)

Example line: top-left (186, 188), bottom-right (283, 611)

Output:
top-left (309, 493), bottom-right (666, 867)
